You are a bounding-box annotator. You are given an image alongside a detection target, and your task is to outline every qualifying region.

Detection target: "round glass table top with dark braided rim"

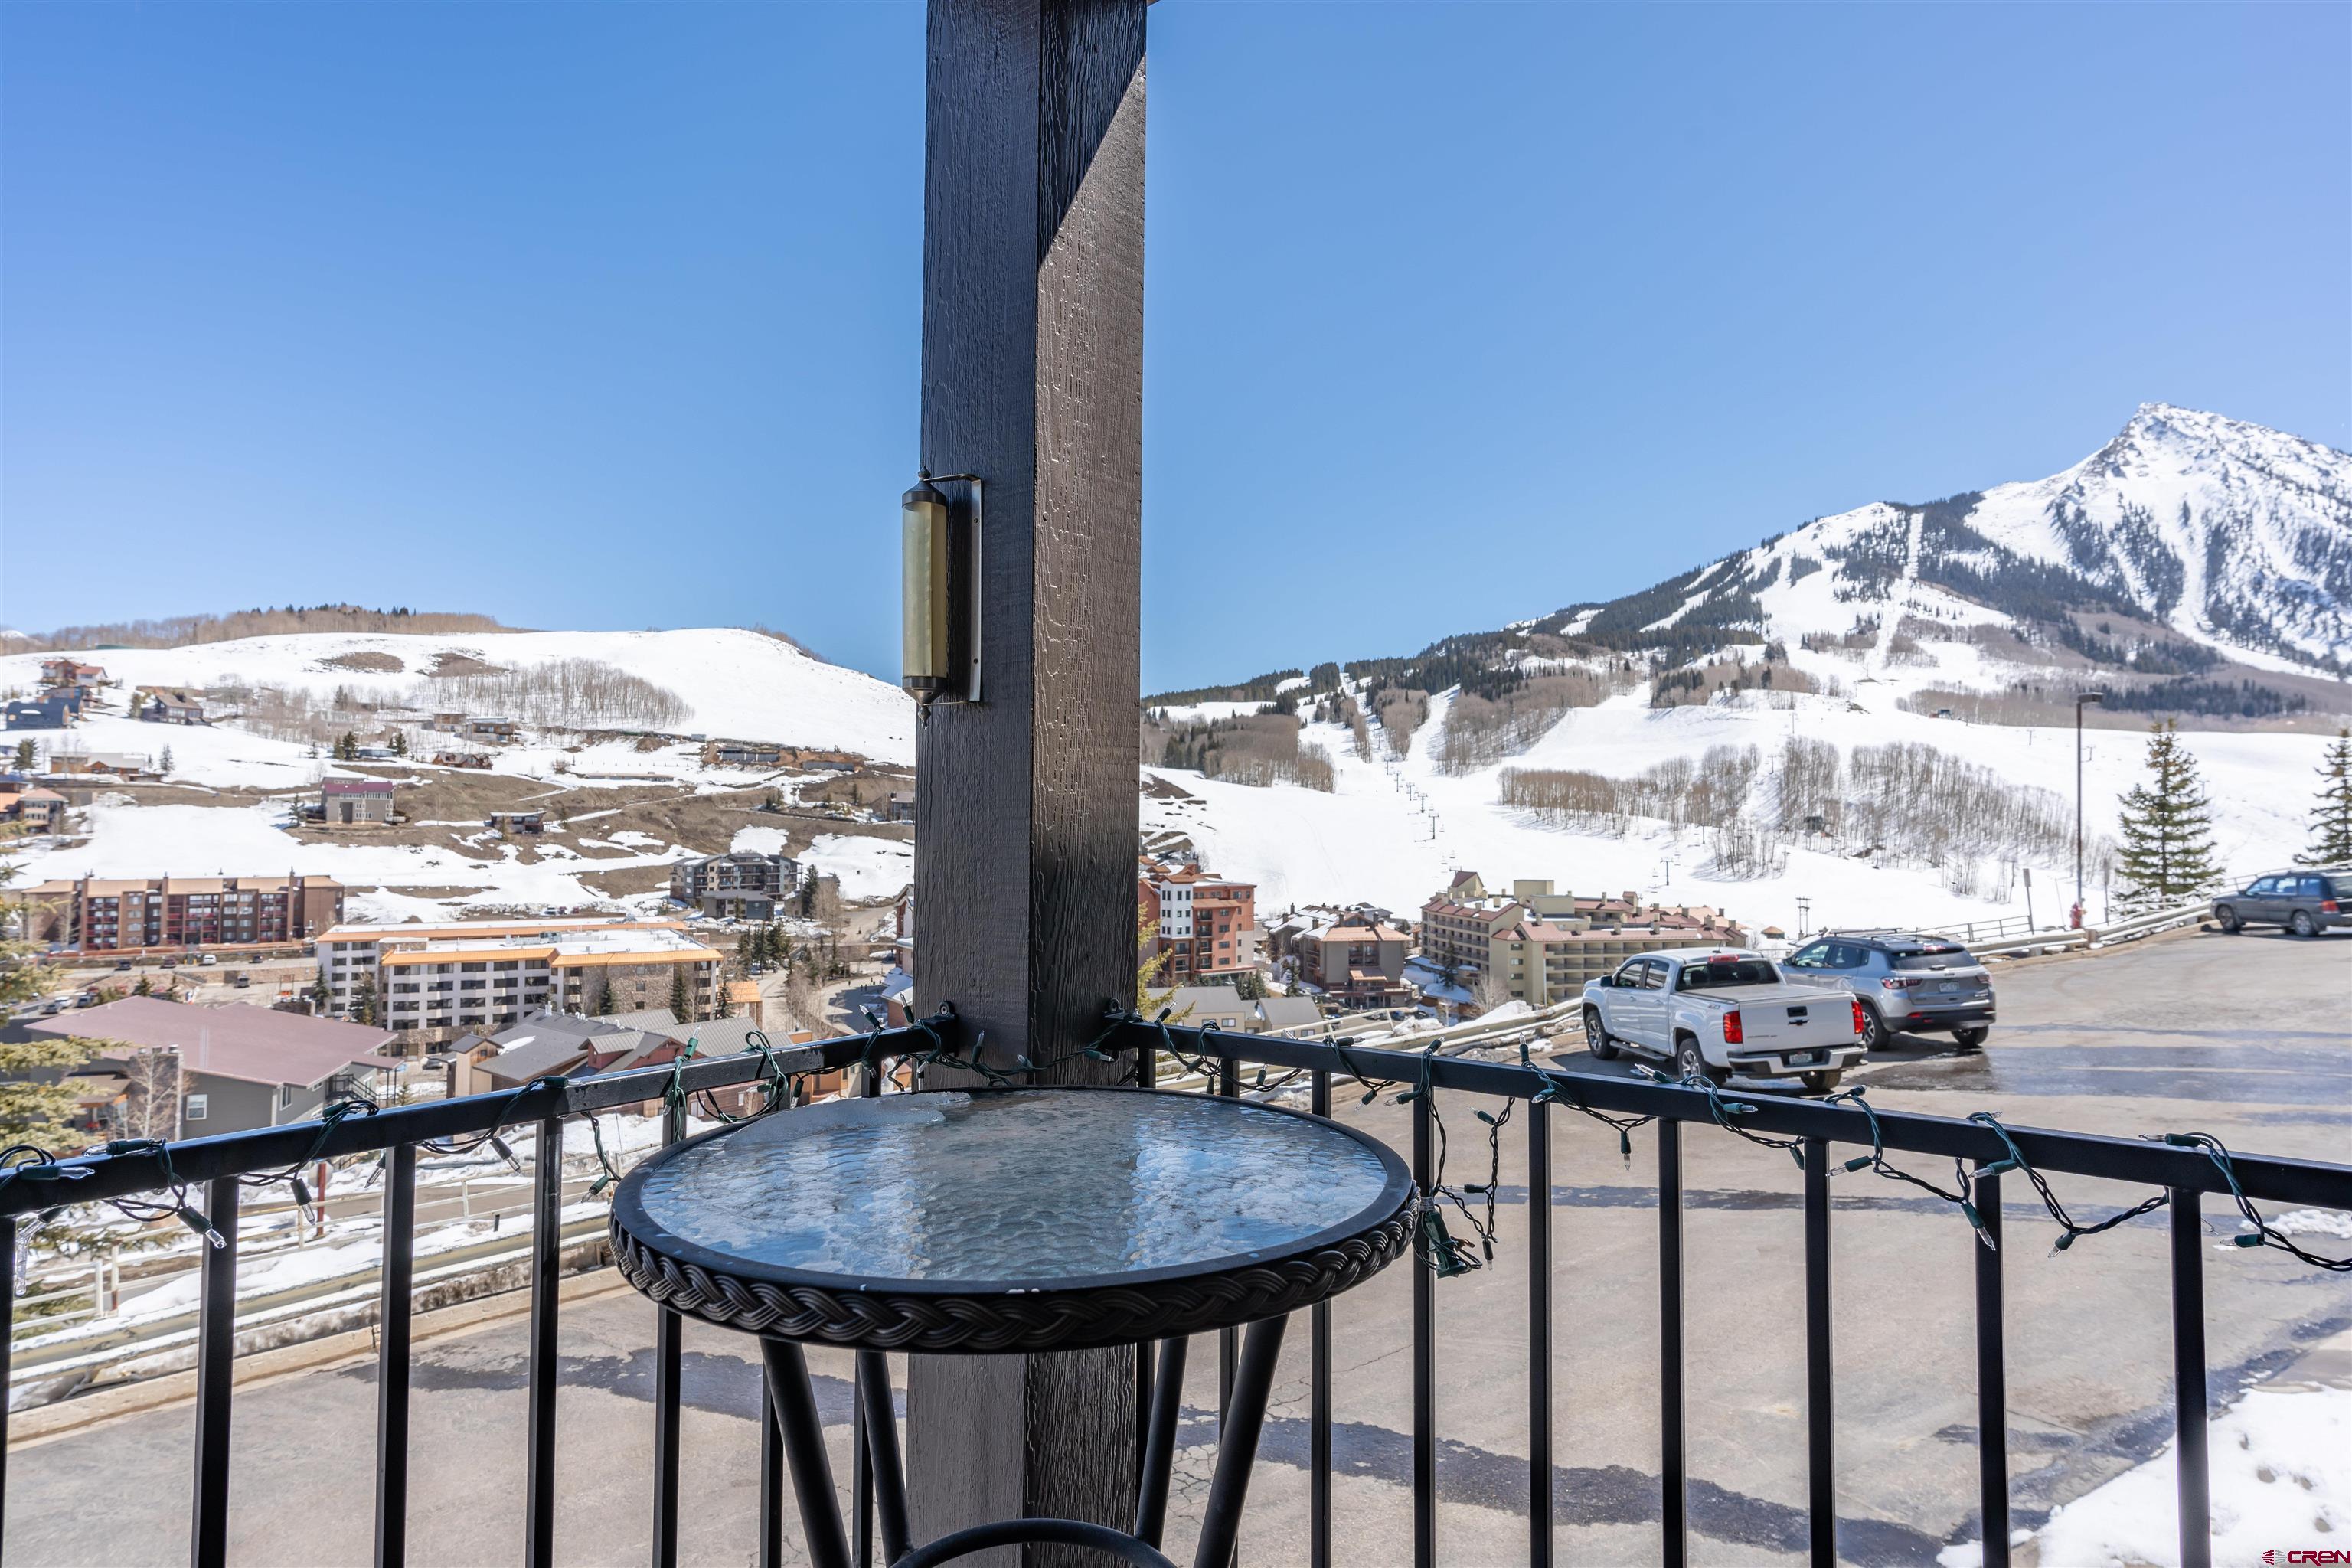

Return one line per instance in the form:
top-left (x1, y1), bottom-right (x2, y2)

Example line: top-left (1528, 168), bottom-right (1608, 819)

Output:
top-left (612, 1089), bottom-right (1413, 1349)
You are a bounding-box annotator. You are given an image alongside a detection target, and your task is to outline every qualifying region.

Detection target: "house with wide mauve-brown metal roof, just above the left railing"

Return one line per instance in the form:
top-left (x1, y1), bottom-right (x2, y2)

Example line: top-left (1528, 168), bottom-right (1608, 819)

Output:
top-left (26, 997), bottom-right (397, 1138)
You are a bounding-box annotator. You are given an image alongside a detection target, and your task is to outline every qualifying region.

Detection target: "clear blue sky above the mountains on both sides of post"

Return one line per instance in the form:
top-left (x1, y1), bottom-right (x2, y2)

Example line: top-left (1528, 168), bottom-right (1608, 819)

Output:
top-left (0, 0), bottom-right (2352, 689)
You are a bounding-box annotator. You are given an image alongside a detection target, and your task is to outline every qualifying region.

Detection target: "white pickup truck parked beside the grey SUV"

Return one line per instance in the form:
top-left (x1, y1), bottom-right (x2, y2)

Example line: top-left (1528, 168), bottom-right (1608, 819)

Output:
top-left (1586, 947), bottom-right (1863, 1093)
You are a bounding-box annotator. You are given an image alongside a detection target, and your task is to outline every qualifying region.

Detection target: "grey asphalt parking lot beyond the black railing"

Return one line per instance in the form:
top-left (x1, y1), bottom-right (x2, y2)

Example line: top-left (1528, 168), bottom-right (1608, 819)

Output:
top-left (7, 931), bottom-right (2352, 1568)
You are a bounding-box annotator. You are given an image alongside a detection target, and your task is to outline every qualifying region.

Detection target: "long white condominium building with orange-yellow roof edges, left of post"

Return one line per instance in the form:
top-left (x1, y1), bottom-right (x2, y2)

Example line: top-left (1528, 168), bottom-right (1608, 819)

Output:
top-left (318, 920), bottom-right (722, 1034)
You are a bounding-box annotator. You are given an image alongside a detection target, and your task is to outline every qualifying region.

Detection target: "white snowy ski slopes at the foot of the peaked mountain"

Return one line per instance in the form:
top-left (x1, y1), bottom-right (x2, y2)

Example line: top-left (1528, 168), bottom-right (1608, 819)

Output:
top-left (1143, 687), bottom-right (2324, 931)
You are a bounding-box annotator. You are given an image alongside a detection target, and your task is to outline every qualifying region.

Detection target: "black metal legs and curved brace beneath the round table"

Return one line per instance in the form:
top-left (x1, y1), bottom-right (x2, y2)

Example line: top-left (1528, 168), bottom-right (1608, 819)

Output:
top-left (760, 1316), bottom-right (1289, 1568)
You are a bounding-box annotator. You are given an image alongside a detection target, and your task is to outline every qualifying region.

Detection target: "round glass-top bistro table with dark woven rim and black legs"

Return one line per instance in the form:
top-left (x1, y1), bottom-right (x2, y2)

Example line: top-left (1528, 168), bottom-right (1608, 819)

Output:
top-left (612, 1089), bottom-right (1418, 1568)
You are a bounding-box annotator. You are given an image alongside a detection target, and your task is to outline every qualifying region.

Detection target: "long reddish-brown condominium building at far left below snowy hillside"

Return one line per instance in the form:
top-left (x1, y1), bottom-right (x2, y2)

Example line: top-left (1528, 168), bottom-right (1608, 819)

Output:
top-left (24, 872), bottom-right (344, 952)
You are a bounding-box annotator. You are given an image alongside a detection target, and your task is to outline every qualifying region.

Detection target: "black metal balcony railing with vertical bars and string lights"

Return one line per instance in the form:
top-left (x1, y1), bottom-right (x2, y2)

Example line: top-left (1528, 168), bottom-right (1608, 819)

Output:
top-left (0, 1018), bottom-right (2352, 1568)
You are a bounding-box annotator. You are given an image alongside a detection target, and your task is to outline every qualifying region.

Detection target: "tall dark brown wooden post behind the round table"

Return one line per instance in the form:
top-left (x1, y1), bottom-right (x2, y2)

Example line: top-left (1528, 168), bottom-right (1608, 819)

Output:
top-left (908, 0), bottom-right (1145, 1563)
